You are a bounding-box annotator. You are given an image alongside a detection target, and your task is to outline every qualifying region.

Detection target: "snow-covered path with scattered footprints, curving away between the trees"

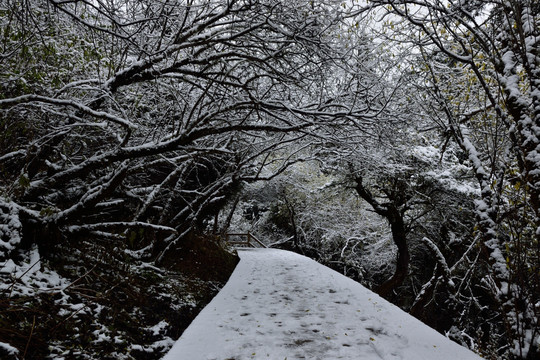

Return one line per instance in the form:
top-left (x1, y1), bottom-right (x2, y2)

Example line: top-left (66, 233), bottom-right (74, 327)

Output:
top-left (164, 249), bottom-right (480, 360)
